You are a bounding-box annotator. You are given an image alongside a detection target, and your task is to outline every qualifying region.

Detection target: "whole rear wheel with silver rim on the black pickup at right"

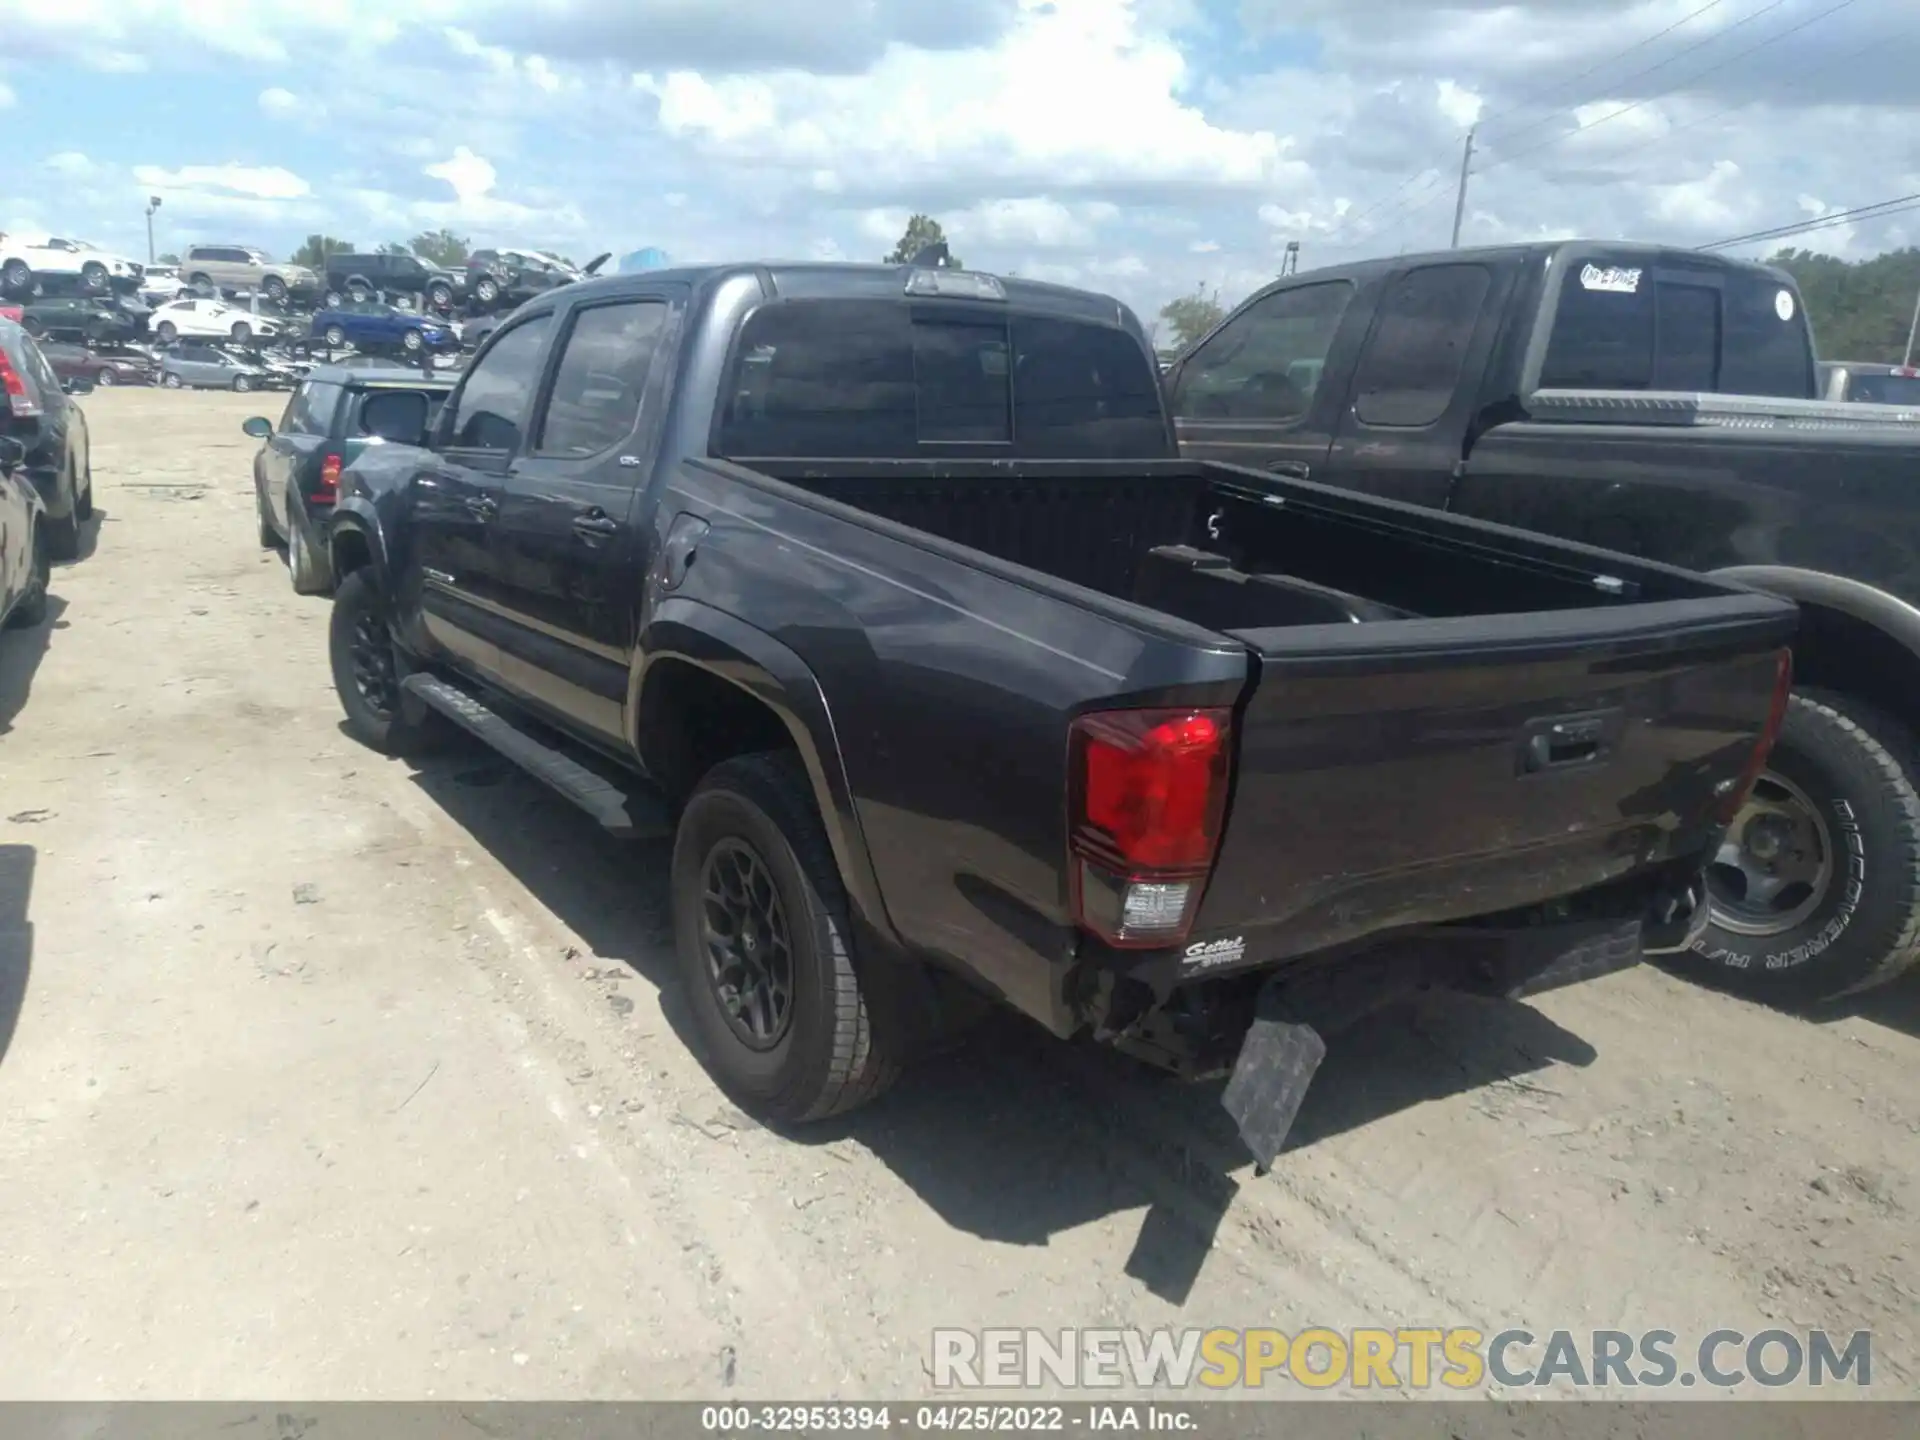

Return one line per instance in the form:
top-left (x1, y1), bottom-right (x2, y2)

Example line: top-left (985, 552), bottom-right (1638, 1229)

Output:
top-left (1676, 689), bottom-right (1920, 1006)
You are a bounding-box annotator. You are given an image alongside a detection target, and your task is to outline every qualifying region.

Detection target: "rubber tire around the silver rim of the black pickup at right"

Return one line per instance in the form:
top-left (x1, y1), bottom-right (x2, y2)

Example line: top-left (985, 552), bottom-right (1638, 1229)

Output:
top-left (1670, 689), bottom-right (1920, 1008)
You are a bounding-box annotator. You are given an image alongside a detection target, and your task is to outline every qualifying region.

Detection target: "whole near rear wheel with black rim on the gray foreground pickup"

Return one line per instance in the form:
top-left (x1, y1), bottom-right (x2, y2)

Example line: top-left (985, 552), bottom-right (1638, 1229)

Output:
top-left (672, 753), bottom-right (900, 1123)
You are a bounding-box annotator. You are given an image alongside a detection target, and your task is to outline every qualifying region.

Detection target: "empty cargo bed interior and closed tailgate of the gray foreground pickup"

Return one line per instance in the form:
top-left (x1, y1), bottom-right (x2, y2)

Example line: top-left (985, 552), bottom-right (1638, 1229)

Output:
top-left (737, 451), bottom-right (1795, 964)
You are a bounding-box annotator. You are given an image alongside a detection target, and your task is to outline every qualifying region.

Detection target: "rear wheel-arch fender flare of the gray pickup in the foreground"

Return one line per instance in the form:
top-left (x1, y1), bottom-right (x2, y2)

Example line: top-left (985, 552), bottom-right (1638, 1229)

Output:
top-left (626, 595), bottom-right (904, 950)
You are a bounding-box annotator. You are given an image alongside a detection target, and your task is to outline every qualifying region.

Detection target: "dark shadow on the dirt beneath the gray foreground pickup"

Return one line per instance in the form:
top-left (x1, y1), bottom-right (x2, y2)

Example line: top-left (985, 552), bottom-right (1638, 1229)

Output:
top-left (415, 745), bottom-right (1596, 1304)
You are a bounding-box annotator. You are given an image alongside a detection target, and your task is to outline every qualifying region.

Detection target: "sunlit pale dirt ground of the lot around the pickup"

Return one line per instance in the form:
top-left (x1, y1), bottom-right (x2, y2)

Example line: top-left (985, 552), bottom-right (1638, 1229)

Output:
top-left (0, 390), bottom-right (1920, 1398)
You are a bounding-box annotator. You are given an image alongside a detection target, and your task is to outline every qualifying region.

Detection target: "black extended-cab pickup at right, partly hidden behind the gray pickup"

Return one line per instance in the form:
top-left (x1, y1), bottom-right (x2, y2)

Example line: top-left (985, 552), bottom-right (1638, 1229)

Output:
top-left (1167, 242), bottom-right (1920, 1002)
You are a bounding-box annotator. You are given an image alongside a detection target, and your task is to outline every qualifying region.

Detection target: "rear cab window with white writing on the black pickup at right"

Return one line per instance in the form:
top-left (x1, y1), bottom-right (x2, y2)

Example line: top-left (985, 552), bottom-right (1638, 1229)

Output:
top-left (1540, 252), bottom-right (1814, 399)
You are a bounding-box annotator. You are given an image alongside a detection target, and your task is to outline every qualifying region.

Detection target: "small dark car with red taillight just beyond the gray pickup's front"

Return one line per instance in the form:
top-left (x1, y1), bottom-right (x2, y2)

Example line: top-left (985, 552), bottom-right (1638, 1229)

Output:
top-left (240, 365), bottom-right (453, 595)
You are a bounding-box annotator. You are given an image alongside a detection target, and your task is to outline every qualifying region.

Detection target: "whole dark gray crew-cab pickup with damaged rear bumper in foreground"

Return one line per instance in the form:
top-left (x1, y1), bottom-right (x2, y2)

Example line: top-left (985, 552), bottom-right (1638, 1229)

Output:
top-left (330, 253), bottom-right (1797, 1164)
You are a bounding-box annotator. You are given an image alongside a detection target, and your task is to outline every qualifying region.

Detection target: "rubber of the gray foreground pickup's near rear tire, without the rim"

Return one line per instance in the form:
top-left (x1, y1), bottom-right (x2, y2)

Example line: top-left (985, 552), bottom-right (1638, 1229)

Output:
top-left (672, 753), bottom-right (902, 1125)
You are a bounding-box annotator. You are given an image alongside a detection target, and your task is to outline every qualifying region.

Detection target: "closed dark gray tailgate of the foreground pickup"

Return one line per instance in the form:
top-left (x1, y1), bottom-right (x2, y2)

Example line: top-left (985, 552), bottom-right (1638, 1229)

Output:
top-left (1192, 589), bottom-right (1797, 962)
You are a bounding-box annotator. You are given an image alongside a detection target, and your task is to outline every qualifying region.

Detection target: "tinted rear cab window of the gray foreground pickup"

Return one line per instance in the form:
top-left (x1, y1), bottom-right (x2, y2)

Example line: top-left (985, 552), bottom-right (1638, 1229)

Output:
top-left (712, 300), bottom-right (1173, 459)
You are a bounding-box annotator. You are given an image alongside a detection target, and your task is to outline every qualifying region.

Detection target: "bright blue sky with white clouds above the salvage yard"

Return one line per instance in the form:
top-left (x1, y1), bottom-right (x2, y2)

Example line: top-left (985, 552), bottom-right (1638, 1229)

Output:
top-left (0, 0), bottom-right (1920, 326)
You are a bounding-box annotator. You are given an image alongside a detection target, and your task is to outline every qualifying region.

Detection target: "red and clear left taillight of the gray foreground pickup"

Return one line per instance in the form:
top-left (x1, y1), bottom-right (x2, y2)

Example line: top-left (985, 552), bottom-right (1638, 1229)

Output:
top-left (1068, 710), bottom-right (1231, 948)
